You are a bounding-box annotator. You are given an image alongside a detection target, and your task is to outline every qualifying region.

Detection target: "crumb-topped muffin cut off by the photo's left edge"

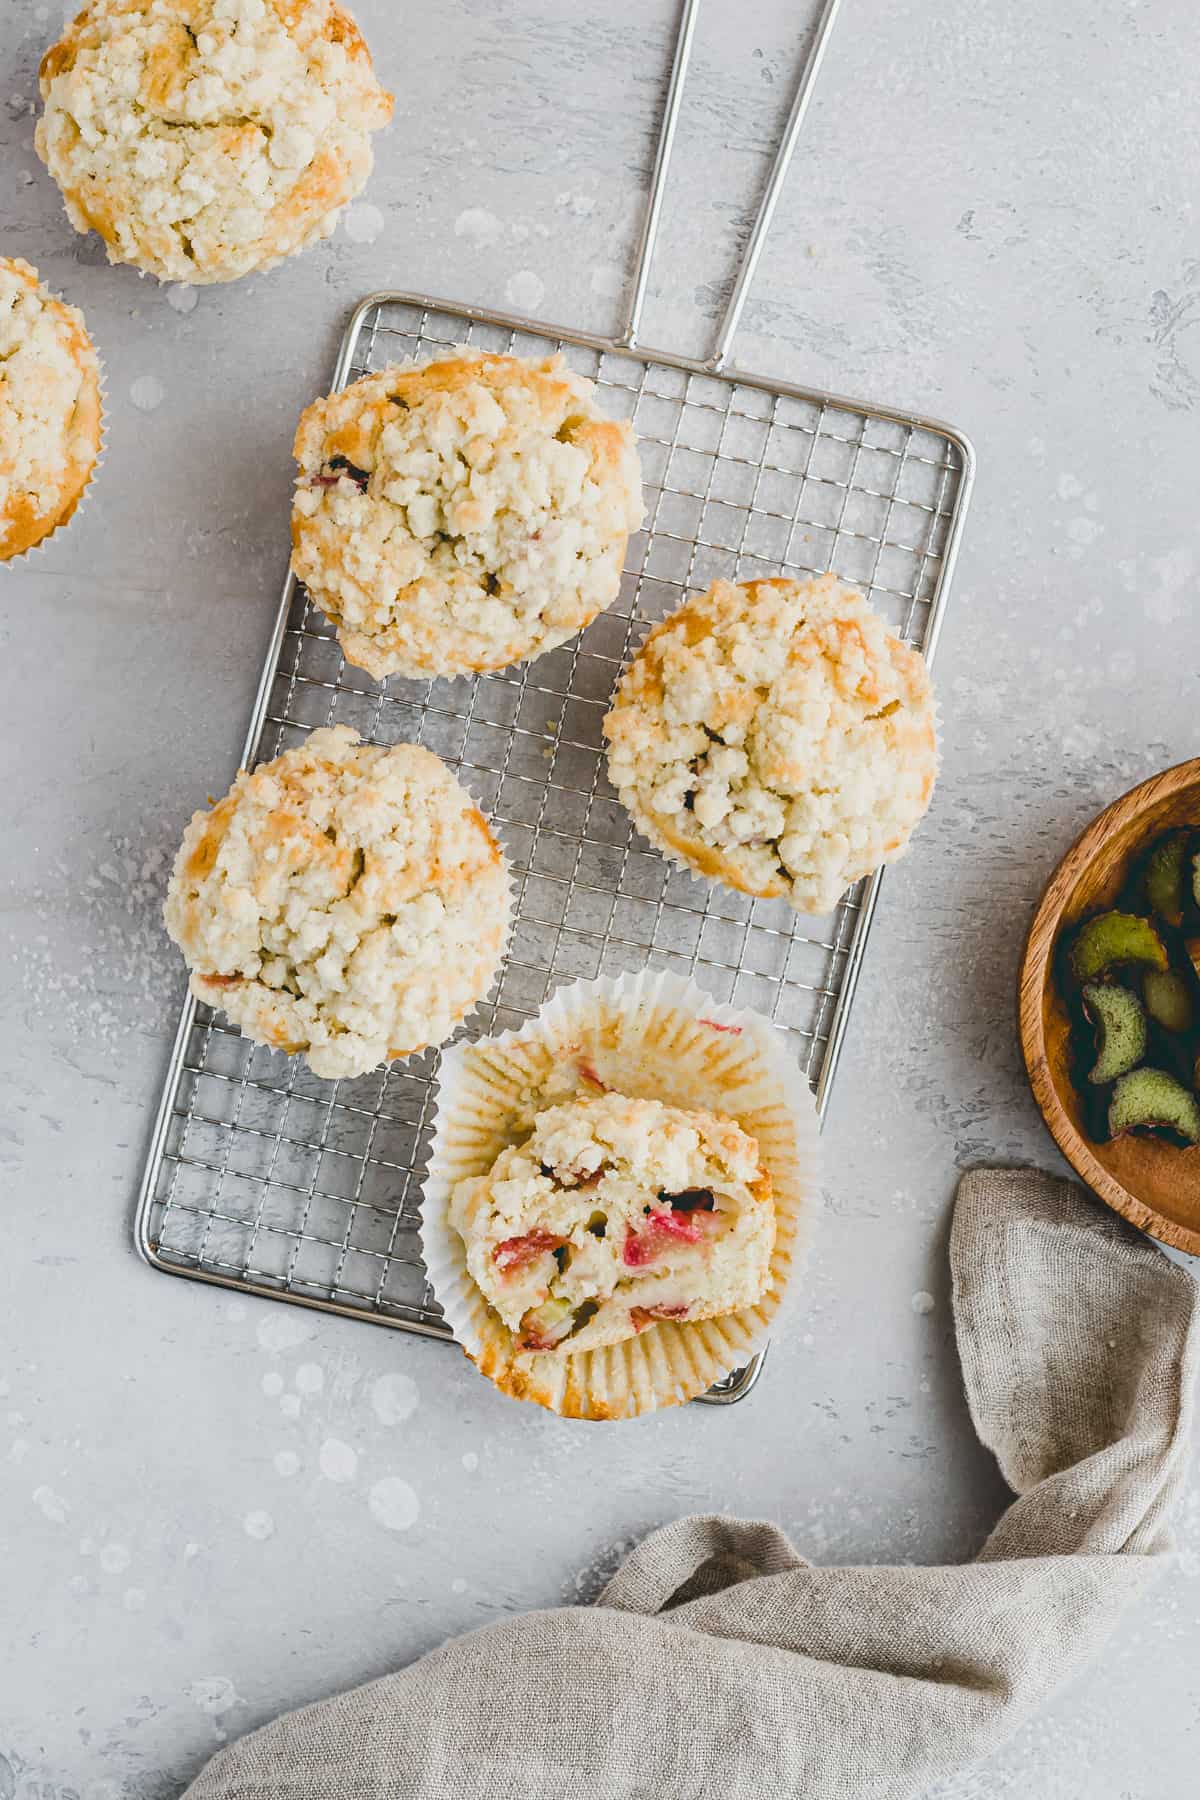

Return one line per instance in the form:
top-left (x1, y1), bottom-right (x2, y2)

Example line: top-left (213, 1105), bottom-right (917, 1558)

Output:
top-left (0, 257), bottom-right (101, 562)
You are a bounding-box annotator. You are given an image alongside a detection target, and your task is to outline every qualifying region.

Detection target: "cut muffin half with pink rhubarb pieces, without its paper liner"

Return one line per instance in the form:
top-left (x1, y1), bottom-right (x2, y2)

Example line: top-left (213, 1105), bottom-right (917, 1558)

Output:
top-left (450, 1093), bottom-right (775, 1355)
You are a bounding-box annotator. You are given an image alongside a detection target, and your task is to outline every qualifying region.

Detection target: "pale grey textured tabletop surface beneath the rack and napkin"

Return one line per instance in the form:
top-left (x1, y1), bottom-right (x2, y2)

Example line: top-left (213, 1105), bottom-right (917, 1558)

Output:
top-left (0, 0), bottom-right (1200, 1800)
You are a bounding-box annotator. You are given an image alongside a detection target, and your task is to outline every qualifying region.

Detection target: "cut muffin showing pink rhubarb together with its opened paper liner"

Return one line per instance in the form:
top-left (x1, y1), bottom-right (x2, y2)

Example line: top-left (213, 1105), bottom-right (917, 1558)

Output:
top-left (421, 970), bottom-right (819, 1420)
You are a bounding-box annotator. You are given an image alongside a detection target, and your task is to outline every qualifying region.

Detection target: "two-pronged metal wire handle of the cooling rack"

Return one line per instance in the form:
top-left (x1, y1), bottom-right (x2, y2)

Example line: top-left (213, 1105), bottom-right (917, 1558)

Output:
top-left (621, 0), bottom-right (842, 369)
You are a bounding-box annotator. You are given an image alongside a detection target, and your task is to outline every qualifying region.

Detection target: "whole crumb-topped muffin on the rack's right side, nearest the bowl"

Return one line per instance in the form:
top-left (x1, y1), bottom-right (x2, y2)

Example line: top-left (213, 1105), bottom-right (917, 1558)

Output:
top-left (604, 574), bottom-right (937, 913)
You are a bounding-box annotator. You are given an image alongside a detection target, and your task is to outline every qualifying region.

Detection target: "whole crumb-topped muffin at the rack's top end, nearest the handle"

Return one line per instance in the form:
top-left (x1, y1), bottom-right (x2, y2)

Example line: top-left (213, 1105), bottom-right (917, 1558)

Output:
top-left (291, 349), bottom-right (642, 679)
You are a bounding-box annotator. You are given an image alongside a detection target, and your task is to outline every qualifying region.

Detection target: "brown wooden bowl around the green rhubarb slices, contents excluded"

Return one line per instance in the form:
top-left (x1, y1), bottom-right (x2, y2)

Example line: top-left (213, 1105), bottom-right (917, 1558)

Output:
top-left (1020, 758), bottom-right (1200, 1256)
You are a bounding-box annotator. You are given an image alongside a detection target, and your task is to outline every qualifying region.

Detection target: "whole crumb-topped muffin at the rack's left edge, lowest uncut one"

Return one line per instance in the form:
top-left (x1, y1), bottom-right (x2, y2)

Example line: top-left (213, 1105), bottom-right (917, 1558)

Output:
top-left (164, 725), bottom-right (509, 1080)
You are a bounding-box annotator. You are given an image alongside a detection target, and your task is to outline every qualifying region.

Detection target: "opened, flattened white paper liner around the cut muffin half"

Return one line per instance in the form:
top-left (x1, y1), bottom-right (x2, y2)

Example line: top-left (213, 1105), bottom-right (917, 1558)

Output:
top-left (421, 972), bottom-right (819, 1418)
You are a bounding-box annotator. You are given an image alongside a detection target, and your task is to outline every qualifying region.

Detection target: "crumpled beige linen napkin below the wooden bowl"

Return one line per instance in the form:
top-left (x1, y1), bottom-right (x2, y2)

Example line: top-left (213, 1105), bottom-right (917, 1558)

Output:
top-left (187, 1170), bottom-right (1200, 1800)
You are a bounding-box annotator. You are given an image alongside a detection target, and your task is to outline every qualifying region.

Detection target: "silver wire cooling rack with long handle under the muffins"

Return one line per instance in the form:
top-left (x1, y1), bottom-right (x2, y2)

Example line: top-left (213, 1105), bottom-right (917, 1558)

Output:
top-left (135, 0), bottom-right (973, 1404)
